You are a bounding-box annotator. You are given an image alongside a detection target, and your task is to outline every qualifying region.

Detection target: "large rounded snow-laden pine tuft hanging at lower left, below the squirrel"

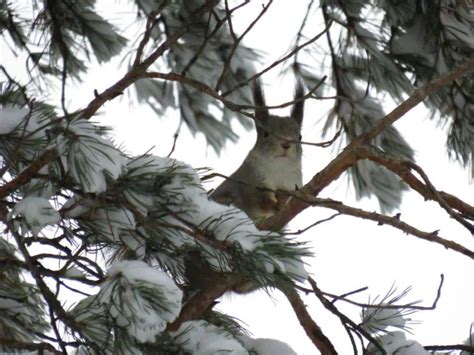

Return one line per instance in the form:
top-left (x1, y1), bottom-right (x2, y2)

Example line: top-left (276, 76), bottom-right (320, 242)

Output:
top-left (97, 260), bottom-right (182, 343)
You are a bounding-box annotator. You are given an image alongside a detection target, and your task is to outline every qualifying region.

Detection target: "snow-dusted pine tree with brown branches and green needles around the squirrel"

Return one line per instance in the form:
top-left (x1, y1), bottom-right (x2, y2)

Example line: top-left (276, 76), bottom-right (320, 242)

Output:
top-left (0, 0), bottom-right (474, 354)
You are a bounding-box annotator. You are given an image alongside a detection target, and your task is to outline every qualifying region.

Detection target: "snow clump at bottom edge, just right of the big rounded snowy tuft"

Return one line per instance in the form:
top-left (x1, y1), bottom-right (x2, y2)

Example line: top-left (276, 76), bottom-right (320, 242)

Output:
top-left (170, 320), bottom-right (248, 355)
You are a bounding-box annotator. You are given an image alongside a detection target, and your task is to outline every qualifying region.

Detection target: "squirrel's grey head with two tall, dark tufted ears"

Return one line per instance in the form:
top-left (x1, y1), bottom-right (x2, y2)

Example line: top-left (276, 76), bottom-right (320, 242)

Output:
top-left (253, 80), bottom-right (304, 159)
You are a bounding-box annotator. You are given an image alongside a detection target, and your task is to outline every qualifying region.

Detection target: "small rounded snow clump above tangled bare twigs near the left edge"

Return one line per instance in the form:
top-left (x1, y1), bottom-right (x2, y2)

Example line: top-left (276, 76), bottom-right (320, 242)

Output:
top-left (13, 196), bottom-right (61, 235)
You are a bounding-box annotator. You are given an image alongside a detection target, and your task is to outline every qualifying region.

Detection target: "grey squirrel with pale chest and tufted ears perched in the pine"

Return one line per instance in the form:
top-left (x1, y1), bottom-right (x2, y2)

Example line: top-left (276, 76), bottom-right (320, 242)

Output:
top-left (186, 81), bottom-right (304, 294)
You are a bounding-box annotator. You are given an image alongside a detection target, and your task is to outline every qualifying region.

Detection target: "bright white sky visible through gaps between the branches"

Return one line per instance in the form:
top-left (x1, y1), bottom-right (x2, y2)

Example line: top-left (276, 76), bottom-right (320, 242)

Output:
top-left (2, 1), bottom-right (474, 354)
